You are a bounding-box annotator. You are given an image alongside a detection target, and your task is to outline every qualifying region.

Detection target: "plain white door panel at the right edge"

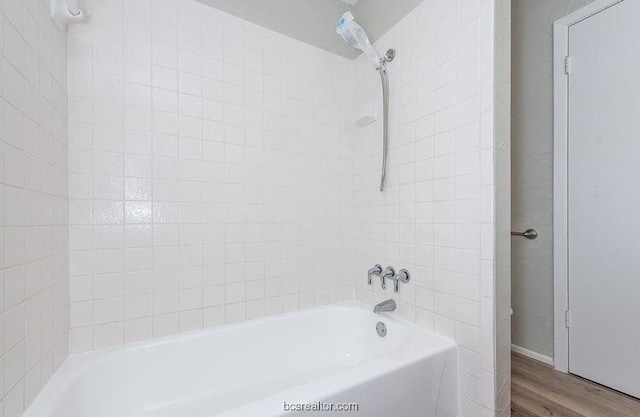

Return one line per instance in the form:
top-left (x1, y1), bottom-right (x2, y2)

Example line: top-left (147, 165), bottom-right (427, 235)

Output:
top-left (568, 0), bottom-right (640, 397)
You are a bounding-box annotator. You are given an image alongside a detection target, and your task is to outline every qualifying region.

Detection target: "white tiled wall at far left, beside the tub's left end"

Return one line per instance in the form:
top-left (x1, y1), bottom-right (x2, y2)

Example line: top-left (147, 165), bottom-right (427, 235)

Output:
top-left (0, 0), bottom-right (69, 417)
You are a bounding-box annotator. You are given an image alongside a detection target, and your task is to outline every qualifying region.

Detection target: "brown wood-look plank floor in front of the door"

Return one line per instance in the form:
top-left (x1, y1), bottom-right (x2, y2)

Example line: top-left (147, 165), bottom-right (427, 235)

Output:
top-left (511, 353), bottom-right (640, 417)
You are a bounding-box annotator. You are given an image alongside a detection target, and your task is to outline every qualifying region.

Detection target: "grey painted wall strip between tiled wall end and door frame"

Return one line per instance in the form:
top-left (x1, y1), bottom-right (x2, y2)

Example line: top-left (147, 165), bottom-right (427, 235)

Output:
top-left (511, 0), bottom-right (591, 357)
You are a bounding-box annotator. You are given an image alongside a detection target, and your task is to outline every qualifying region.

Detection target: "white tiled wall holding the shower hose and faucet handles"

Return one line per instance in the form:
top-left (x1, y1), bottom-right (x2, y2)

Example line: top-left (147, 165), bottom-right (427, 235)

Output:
top-left (353, 0), bottom-right (496, 416)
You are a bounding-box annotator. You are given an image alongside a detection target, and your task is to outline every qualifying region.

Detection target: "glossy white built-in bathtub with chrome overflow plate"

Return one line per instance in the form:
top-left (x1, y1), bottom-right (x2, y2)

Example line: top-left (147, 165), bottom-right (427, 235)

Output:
top-left (25, 303), bottom-right (458, 417)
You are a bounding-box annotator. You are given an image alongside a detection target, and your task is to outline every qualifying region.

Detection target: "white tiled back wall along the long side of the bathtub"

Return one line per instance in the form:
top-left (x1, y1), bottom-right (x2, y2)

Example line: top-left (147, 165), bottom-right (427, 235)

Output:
top-left (68, 0), bottom-right (353, 352)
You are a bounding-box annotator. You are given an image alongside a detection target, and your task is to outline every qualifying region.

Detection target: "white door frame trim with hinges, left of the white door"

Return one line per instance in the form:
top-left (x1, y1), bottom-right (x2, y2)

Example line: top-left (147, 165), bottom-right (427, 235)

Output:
top-left (553, 0), bottom-right (625, 373)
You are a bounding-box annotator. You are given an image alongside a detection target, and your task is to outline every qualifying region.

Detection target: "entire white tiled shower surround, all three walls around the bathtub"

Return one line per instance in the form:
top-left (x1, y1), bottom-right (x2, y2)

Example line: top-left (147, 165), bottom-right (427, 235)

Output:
top-left (0, 0), bottom-right (509, 417)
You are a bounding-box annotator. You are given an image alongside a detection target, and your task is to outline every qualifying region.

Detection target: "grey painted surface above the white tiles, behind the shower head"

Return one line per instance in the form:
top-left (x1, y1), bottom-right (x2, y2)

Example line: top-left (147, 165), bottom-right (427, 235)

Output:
top-left (198, 0), bottom-right (422, 59)
